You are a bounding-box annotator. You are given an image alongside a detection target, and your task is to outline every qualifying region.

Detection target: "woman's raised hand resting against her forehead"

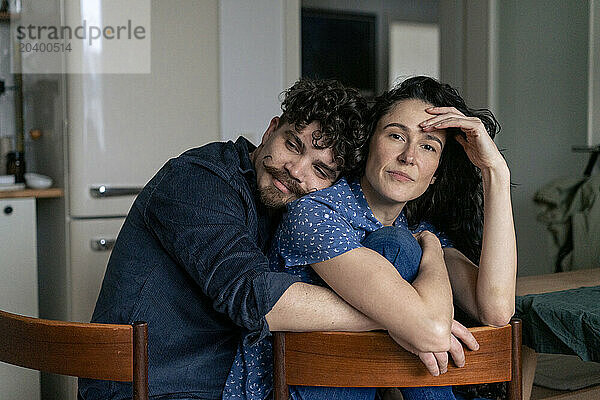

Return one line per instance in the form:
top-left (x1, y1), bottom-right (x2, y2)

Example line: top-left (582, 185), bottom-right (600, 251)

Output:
top-left (420, 107), bottom-right (506, 170)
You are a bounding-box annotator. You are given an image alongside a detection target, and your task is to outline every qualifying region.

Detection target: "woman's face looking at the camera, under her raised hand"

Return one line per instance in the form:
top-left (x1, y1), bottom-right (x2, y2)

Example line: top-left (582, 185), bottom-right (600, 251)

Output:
top-left (362, 99), bottom-right (446, 207)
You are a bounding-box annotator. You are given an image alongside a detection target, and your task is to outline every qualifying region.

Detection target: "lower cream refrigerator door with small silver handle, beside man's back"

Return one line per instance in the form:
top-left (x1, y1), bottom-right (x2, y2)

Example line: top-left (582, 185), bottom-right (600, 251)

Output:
top-left (70, 218), bottom-right (125, 322)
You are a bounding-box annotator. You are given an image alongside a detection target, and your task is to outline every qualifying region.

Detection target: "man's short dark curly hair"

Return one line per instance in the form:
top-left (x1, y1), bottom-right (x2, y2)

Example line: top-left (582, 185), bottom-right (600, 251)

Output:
top-left (280, 78), bottom-right (368, 174)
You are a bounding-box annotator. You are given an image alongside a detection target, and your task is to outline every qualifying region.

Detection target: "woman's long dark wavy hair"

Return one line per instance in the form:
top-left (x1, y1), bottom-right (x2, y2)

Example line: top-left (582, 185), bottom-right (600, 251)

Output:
top-left (360, 76), bottom-right (500, 263)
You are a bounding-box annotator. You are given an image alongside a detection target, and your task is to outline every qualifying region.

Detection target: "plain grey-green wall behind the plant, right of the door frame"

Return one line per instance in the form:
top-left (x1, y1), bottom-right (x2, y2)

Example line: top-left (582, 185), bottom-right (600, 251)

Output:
top-left (497, 0), bottom-right (589, 275)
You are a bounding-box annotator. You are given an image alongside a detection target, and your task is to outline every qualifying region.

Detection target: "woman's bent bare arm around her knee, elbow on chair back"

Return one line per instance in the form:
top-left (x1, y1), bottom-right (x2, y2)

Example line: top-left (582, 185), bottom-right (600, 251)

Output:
top-left (312, 232), bottom-right (453, 352)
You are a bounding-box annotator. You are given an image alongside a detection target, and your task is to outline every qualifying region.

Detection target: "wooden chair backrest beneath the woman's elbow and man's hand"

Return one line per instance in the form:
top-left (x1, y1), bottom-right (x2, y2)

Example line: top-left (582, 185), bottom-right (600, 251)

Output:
top-left (274, 319), bottom-right (522, 400)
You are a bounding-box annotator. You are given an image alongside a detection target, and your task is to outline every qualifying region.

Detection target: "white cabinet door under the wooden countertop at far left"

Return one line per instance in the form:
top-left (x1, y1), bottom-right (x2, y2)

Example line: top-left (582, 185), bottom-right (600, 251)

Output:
top-left (0, 198), bottom-right (40, 400)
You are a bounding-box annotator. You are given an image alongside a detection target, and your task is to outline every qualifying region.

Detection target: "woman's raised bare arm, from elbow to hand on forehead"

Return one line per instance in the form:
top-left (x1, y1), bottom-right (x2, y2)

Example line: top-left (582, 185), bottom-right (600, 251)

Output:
top-left (422, 107), bottom-right (517, 326)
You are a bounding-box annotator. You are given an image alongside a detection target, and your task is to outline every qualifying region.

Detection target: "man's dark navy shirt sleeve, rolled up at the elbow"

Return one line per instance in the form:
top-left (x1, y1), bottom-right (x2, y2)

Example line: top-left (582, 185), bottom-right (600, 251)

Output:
top-left (143, 159), bottom-right (299, 335)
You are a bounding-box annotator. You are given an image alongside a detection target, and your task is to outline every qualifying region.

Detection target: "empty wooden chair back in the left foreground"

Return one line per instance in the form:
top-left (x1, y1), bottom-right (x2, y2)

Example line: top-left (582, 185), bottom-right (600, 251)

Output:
top-left (0, 311), bottom-right (148, 400)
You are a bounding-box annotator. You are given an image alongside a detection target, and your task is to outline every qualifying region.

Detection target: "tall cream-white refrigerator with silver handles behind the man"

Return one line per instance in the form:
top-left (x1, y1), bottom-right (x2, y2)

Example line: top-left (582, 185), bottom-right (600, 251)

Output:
top-left (33, 0), bottom-right (220, 400)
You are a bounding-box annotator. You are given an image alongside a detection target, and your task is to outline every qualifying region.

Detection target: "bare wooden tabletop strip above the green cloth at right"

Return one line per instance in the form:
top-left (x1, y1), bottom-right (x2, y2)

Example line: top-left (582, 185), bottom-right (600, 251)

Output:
top-left (517, 268), bottom-right (600, 296)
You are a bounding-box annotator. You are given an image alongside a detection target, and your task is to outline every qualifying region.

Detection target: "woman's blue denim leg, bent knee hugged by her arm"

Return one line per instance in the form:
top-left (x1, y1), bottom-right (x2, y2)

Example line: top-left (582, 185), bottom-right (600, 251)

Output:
top-left (362, 226), bottom-right (456, 400)
